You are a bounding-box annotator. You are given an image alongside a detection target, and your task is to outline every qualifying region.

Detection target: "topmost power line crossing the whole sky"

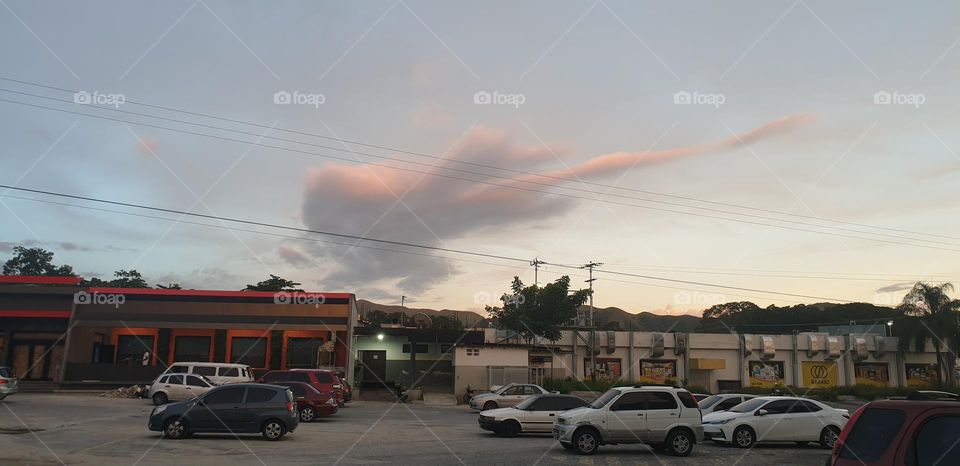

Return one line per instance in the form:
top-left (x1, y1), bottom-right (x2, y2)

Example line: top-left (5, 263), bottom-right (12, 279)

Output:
top-left (0, 76), bottom-right (960, 244)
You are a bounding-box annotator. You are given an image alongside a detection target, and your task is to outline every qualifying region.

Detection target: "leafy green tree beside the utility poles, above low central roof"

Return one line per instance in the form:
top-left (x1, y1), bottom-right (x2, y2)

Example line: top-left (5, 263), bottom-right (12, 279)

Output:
top-left (486, 275), bottom-right (590, 341)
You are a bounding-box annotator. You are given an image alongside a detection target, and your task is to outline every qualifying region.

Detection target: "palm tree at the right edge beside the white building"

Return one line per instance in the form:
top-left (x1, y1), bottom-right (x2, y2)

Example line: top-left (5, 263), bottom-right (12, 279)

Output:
top-left (896, 282), bottom-right (960, 386)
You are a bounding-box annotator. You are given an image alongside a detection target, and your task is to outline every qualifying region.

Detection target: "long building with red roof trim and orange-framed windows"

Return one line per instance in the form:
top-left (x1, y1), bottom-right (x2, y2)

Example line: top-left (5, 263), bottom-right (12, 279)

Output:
top-left (0, 276), bottom-right (357, 386)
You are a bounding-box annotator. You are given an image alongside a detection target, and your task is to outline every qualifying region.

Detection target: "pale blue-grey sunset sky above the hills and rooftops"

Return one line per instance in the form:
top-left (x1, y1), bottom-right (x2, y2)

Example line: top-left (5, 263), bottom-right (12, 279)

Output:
top-left (0, 0), bottom-right (960, 314)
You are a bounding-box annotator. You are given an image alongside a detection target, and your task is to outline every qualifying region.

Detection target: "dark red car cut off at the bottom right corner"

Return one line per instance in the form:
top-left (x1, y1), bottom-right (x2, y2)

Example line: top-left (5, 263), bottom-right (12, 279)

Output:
top-left (827, 400), bottom-right (960, 466)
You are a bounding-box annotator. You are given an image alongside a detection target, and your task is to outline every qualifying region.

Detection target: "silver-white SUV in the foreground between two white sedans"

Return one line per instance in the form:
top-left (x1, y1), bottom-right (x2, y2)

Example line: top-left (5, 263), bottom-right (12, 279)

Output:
top-left (553, 385), bottom-right (703, 456)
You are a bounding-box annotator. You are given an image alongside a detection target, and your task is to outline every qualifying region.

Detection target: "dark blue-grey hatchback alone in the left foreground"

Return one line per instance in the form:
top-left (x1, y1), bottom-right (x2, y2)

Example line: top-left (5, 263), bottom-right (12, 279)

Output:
top-left (147, 384), bottom-right (300, 440)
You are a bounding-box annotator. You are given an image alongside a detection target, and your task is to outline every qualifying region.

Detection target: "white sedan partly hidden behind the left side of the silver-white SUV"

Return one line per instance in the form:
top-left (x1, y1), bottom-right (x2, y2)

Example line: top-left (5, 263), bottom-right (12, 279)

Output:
top-left (477, 394), bottom-right (587, 437)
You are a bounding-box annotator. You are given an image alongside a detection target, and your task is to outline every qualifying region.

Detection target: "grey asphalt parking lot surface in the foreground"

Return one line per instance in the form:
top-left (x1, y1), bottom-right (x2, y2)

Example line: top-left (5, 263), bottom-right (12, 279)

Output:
top-left (0, 393), bottom-right (828, 466)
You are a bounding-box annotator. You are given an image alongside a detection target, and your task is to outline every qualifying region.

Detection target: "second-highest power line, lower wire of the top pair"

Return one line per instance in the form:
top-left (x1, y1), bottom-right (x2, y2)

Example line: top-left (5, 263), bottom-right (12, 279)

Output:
top-left (0, 99), bottom-right (960, 252)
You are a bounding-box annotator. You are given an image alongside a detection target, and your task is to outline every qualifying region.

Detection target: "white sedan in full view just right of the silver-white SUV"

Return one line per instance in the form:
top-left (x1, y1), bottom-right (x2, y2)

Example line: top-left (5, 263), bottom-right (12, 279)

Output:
top-left (703, 396), bottom-right (850, 448)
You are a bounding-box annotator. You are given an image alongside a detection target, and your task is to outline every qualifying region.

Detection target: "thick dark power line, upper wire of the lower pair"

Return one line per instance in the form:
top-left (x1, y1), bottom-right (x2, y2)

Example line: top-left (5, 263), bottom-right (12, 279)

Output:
top-left (0, 184), bottom-right (851, 302)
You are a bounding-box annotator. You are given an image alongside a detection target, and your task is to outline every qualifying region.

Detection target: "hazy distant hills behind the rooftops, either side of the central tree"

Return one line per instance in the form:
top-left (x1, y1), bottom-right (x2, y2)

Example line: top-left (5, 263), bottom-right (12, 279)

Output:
top-left (357, 299), bottom-right (700, 332)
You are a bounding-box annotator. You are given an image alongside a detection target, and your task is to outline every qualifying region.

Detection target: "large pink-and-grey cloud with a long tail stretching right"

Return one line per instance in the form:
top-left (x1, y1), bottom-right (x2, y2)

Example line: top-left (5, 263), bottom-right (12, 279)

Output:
top-left (296, 115), bottom-right (810, 294)
